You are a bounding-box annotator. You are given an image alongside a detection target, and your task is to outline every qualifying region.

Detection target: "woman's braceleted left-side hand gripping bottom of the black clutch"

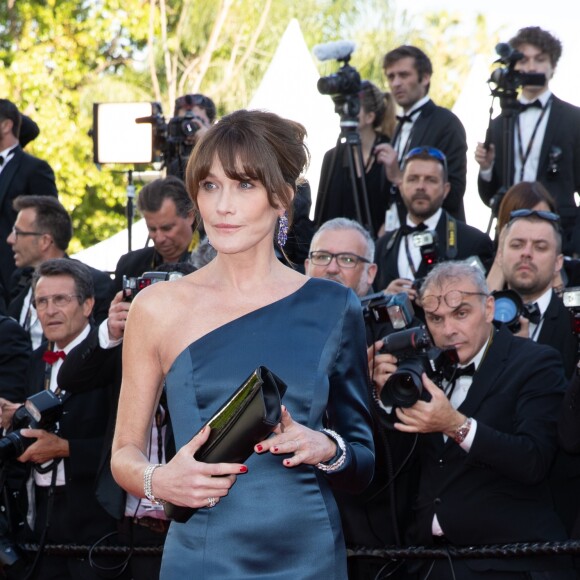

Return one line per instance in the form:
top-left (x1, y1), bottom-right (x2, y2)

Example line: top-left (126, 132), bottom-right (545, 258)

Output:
top-left (151, 427), bottom-right (248, 508)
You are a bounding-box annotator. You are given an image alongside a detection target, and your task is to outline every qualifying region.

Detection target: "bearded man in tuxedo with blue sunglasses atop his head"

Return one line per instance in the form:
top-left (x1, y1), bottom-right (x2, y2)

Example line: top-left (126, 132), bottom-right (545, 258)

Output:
top-left (375, 147), bottom-right (493, 300)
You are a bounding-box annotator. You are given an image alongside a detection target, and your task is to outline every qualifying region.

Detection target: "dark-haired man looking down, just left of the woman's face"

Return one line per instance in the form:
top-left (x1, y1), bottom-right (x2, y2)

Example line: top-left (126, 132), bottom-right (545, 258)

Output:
top-left (114, 175), bottom-right (201, 292)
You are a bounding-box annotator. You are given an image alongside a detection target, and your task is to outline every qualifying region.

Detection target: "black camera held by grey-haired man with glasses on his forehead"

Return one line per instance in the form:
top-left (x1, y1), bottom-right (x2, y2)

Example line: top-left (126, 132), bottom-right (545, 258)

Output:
top-left (381, 326), bottom-right (459, 407)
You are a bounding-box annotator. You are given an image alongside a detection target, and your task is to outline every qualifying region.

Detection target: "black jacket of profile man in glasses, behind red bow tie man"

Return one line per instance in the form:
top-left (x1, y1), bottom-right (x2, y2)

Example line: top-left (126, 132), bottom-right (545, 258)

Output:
top-left (7, 256), bottom-right (115, 324)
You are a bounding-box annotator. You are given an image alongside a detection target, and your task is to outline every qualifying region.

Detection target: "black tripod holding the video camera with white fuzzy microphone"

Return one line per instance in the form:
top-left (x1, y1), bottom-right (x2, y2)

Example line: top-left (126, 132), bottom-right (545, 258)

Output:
top-left (316, 94), bottom-right (376, 238)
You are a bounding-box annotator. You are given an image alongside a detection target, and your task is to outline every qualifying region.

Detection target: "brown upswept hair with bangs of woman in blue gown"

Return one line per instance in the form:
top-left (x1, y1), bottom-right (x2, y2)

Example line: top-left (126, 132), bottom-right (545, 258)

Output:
top-left (185, 109), bottom-right (310, 222)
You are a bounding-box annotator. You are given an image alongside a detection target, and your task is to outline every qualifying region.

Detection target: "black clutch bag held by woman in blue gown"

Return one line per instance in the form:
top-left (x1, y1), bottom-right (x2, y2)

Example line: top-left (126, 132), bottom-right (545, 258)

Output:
top-left (164, 366), bottom-right (286, 523)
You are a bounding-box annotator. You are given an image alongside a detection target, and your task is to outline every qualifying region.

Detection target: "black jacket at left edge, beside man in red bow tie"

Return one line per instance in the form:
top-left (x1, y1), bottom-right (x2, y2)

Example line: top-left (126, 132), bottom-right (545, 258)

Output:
top-left (0, 315), bottom-right (31, 402)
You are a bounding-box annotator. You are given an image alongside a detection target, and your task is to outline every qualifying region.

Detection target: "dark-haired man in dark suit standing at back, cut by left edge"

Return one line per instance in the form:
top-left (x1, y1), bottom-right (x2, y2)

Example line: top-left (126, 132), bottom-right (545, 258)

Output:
top-left (0, 99), bottom-right (57, 291)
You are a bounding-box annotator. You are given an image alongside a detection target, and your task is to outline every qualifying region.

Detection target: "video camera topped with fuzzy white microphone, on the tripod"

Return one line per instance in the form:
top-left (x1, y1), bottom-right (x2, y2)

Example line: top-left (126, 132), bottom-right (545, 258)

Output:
top-left (313, 40), bottom-right (361, 130)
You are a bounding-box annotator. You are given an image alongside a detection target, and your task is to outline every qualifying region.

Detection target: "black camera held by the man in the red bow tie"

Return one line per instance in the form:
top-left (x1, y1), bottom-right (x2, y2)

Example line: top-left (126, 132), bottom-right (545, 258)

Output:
top-left (0, 390), bottom-right (63, 460)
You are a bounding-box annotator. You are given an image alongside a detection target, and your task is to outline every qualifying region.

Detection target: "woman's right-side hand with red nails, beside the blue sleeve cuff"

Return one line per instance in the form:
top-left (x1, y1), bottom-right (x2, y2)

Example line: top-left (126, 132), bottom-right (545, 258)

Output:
top-left (254, 406), bottom-right (337, 467)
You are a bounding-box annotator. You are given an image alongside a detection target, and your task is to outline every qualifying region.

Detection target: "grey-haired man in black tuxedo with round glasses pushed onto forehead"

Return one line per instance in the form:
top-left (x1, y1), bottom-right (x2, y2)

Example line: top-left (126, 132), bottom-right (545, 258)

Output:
top-left (388, 262), bottom-right (576, 580)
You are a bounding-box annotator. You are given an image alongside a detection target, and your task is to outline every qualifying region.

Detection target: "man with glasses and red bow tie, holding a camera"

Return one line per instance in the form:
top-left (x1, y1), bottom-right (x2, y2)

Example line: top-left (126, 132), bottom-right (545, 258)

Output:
top-left (2, 259), bottom-right (115, 580)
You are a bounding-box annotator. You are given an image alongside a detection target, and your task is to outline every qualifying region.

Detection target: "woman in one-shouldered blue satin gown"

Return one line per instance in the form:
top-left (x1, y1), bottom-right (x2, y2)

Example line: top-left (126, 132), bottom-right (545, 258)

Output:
top-left (112, 111), bottom-right (374, 580)
